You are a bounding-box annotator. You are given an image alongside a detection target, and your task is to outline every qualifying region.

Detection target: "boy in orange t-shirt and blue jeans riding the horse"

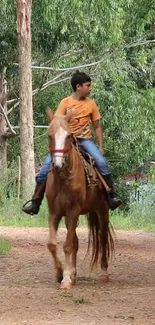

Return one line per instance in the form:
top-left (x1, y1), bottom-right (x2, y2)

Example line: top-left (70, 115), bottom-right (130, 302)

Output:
top-left (23, 71), bottom-right (121, 215)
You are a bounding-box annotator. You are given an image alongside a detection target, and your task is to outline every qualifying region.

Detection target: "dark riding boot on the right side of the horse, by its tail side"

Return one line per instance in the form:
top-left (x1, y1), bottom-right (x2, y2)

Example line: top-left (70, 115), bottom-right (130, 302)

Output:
top-left (103, 174), bottom-right (122, 210)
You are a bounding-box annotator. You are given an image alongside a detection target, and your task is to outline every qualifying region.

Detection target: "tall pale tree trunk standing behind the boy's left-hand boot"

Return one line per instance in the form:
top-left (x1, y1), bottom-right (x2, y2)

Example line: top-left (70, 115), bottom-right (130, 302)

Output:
top-left (17, 0), bottom-right (35, 198)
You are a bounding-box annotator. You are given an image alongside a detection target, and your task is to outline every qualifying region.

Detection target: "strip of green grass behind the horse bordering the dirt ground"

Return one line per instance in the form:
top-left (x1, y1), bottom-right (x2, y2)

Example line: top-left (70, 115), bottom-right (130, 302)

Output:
top-left (0, 197), bottom-right (155, 232)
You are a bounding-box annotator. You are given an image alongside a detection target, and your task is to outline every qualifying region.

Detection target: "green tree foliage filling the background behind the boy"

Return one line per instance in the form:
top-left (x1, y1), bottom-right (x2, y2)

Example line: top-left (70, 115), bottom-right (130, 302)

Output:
top-left (0, 0), bottom-right (155, 213)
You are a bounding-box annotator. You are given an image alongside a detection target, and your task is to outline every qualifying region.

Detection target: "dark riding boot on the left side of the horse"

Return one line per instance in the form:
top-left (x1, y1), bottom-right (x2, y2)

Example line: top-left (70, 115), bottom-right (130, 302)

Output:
top-left (22, 180), bottom-right (46, 215)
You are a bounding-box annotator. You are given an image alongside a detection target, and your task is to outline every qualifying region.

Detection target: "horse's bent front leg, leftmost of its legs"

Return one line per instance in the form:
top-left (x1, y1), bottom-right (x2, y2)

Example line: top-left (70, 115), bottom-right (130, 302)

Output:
top-left (47, 215), bottom-right (63, 283)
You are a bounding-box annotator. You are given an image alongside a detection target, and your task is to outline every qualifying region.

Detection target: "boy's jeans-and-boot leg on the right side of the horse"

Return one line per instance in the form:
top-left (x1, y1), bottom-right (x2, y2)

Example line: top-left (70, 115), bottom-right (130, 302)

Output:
top-left (78, 138), bottom-right (121, 210)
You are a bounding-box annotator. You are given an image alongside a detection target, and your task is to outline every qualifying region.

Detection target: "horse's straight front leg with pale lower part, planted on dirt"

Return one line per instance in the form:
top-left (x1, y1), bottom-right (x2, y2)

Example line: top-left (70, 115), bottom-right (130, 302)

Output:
top-left (60, 212), bottom-right (79, 289)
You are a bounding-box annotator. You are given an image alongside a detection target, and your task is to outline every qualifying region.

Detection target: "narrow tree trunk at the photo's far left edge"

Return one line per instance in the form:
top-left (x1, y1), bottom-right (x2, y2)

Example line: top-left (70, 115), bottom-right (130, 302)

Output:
top-left (0, 73), bottom-right (7, 181)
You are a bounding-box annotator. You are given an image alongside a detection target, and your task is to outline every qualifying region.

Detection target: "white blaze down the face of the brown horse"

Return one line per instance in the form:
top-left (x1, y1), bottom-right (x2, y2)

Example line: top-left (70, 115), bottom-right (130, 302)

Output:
top-left (53, 127), bottom-right (68, 168)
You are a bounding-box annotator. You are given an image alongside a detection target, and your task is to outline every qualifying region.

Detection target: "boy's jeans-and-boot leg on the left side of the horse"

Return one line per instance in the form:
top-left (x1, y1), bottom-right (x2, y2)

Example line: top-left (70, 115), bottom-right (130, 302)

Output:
top-left (22, 154), bottom-right (52, 215)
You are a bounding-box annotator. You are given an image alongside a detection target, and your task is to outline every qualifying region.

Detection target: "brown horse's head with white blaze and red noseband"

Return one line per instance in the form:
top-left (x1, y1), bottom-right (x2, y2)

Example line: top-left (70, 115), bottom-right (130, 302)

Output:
top-left (47, 109), bottom-right (72, 168)
